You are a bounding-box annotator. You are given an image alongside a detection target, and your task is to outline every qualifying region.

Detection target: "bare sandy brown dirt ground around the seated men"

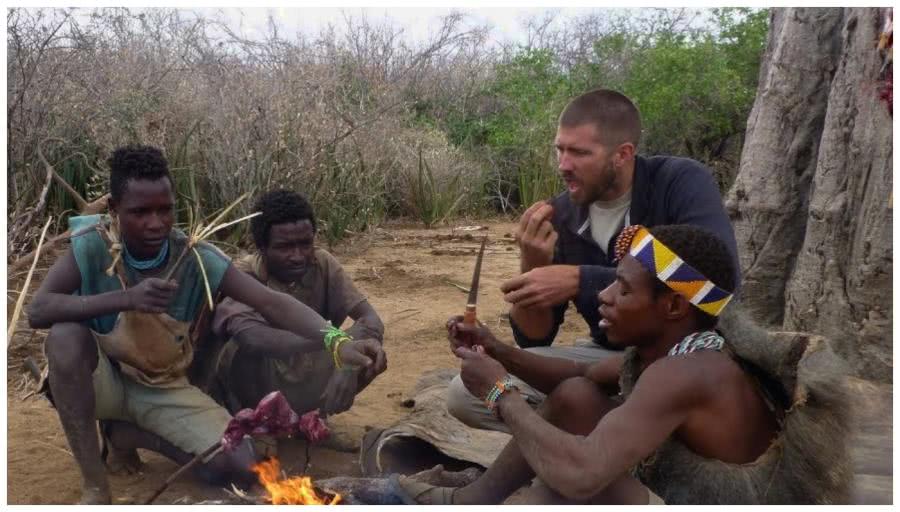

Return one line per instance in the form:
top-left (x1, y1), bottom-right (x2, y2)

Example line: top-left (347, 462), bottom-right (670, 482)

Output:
top-left (7, 221), bottom-right (892, 504)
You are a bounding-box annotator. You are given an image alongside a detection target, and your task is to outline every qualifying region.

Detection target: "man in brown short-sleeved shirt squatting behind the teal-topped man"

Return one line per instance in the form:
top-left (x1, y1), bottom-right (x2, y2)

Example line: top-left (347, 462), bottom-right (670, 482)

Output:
top-left (202, 190), bottom-right (387, 422)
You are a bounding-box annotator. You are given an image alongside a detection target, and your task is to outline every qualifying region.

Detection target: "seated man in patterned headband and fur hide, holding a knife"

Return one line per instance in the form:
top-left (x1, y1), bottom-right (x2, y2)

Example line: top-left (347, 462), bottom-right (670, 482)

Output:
top-left (397, 225), bottom-right (852, 504)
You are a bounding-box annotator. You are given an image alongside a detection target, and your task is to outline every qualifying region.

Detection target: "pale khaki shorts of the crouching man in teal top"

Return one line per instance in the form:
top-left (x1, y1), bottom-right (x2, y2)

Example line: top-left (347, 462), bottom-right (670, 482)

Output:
top-left (93, 338), bottom-right (231, 454)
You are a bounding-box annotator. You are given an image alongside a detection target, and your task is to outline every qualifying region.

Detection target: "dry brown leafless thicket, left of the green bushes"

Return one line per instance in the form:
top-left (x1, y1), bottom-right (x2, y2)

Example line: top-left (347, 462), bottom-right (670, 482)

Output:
top-left (7, 9), bottom-right (496, 256)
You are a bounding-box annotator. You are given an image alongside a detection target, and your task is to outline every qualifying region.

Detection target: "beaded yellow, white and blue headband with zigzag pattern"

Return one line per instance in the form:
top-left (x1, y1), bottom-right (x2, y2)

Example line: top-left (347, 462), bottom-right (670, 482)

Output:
top-left (616, 226), bottom-right (732, 316)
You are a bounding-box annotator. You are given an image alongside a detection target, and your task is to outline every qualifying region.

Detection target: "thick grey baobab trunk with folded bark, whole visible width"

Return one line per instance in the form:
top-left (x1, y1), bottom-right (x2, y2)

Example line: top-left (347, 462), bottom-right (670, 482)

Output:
top-left (726, 8), bottom-right (893, 380)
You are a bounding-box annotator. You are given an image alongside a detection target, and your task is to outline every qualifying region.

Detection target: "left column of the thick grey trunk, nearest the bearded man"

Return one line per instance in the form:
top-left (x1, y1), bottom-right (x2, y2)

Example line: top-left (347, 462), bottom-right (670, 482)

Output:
top-left (726, 9), bottom-right (843, 327)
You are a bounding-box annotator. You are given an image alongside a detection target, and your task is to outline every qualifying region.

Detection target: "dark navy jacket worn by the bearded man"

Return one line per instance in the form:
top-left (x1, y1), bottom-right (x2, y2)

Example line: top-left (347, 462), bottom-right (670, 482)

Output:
top-left (512, 156), bottom-right (740, 347)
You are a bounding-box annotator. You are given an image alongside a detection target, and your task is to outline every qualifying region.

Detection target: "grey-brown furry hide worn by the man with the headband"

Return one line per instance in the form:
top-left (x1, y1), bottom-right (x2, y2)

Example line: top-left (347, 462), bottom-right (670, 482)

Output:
top-left (622, 304), bottom-right (853, 504)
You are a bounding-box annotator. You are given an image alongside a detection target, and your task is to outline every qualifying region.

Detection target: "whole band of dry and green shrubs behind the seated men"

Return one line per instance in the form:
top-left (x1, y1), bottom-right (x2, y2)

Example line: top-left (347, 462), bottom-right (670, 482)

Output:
top-left (7, 9), bottom-right (769, 253)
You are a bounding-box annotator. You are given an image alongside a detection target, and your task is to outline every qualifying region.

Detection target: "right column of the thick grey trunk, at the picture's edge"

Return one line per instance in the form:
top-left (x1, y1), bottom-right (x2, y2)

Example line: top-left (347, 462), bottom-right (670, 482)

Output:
top-left (784, 8), bottom-right (893, 381)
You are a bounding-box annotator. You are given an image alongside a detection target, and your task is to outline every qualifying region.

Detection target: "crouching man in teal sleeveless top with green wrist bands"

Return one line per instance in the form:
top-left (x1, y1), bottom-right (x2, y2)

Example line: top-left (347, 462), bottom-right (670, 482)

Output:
top-left (28, 146), bottom-right (380, 504)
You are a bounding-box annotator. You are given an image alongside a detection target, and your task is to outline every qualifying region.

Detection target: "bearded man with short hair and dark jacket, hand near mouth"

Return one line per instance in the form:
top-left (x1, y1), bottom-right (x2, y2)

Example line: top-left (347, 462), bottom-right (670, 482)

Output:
top-left (447, 89), bottom-right (740, 431)
